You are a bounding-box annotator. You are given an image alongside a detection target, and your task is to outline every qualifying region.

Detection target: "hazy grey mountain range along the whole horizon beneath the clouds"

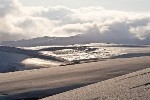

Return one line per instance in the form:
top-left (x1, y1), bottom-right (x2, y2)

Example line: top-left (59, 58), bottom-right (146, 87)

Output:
top-left (0, 32), bottom-right (149, 47)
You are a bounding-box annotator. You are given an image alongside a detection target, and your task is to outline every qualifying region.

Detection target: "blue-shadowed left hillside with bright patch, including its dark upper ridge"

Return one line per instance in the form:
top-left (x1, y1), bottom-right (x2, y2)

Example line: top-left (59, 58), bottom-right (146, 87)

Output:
top-left (0, 46), bottom-right (62, 73)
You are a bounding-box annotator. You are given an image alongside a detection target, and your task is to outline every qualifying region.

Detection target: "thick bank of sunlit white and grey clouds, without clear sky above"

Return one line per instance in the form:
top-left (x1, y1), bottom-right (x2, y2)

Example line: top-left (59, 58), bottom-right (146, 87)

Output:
top-left (0, 0), bottom-right (150, 44)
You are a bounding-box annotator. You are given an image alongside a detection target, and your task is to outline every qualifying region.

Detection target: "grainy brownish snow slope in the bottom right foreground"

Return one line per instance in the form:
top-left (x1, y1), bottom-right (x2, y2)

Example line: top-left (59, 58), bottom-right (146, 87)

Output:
top-left (42, 68), bottom-right (150, 100)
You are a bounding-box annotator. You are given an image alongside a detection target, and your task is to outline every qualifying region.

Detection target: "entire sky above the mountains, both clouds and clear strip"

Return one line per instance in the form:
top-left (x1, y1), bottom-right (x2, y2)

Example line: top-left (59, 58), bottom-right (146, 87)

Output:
top-left (0, 0), bottom-right (150, 44)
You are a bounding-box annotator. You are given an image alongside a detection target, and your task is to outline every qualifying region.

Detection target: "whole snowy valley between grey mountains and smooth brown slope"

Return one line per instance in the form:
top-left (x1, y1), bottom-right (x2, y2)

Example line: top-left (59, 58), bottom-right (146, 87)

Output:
top-left (0, 43), bottom-right (150, 72)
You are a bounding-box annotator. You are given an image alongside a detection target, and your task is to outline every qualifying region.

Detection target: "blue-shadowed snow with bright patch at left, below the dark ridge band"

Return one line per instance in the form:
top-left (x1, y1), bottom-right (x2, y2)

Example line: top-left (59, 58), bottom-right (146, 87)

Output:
top-left (0, 51), bottom-right (63, 72)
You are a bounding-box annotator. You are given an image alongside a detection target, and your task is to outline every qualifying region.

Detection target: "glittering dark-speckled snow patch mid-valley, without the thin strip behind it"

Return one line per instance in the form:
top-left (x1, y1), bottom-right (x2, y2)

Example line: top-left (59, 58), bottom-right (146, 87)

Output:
top-left (41, 47), bottom-right (123, 61)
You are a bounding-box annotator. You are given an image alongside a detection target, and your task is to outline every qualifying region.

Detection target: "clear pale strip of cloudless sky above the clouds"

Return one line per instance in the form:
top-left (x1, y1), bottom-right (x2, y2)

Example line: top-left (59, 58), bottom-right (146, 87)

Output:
top-left (20, 0), bottom-right (150, 12)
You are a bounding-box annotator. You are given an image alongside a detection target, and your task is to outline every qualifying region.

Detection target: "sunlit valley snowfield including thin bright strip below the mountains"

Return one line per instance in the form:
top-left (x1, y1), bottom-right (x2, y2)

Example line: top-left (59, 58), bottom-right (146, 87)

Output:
top-left (21, 43), bottom-right (150, 61)
